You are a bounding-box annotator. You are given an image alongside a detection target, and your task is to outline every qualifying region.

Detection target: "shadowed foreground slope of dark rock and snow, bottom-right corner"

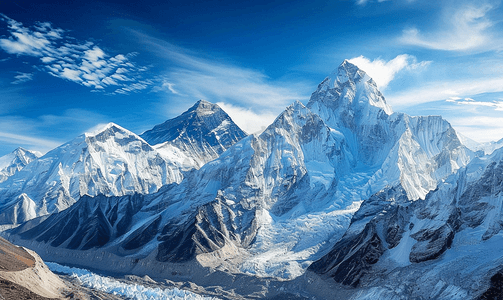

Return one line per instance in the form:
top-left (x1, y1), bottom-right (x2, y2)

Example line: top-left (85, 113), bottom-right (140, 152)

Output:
top-left (311, 149), bottom-right (503, 299)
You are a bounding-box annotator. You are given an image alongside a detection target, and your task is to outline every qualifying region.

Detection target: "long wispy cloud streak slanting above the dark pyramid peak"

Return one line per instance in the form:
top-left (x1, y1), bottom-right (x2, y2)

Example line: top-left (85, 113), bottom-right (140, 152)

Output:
top-left (133, 31), bottom-right (313, 129)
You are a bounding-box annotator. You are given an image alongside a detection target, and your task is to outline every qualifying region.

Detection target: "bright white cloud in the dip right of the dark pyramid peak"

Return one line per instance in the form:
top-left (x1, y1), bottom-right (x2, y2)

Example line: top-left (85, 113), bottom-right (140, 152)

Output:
top-left (217, 102), bottom-right (276, 134)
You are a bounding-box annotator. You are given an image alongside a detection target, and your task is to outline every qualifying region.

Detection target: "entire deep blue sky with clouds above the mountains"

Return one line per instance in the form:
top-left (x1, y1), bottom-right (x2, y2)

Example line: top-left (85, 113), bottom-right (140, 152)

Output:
top-left (0, 0), bottom-right (503, 155)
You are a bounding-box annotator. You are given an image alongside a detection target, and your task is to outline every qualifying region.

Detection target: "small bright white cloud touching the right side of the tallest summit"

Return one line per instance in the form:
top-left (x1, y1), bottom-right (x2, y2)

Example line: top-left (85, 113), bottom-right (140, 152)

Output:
top-left (349, 54), bottom-right (431, 89)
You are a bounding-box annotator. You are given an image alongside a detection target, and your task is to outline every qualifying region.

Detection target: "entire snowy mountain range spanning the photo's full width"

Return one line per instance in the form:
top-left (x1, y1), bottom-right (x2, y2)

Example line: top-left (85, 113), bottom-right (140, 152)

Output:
top-left (0, 61), bottom-right (503, 299)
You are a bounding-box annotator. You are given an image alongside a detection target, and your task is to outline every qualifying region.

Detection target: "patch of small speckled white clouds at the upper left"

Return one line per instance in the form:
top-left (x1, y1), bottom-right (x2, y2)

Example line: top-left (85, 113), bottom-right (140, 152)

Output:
top-left (0, 14), bottom-right (152, 94)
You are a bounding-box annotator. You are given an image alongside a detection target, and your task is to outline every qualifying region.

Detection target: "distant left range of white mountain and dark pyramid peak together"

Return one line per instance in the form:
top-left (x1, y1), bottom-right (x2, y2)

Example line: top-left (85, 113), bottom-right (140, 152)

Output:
top-left (0, 100), bottom-right (246, 224)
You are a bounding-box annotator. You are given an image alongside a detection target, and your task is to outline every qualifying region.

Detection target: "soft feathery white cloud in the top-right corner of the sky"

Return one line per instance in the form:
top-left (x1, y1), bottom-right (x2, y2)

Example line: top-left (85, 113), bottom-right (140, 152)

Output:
top-left (400, 2), bottom-right (501, 51)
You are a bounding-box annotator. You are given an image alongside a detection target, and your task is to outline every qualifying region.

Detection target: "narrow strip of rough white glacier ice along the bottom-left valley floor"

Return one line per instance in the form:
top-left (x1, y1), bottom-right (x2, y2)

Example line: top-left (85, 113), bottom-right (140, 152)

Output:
top-left (46, 262), bottom-right (218, 300)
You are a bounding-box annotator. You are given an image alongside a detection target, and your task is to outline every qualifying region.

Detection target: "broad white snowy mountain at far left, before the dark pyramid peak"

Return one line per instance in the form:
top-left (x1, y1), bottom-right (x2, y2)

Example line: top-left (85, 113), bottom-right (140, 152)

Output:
top-left (0, 123), bottom-right (182, 224)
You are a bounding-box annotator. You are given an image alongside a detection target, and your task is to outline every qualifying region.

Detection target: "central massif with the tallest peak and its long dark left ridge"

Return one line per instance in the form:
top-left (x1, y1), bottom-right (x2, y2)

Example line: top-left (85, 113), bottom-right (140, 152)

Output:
top-left (9, 61), bottom-right (473, 284)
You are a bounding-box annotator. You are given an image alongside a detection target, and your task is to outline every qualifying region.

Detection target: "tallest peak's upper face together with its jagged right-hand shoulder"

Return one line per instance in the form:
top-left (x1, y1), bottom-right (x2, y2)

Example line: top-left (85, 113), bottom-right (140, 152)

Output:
top-left (307, 61), bottom-right (474, 199)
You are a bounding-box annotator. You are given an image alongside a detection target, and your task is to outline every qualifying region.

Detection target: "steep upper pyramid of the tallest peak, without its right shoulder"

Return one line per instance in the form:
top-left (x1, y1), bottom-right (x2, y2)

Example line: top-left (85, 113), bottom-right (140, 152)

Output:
top-left (307, 61), bottom-right (394, 166)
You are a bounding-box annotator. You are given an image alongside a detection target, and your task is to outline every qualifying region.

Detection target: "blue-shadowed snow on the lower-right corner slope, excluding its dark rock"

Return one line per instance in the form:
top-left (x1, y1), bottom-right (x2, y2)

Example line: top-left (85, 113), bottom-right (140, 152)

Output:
top-left (344, 145), bottom-right (503, 299)
